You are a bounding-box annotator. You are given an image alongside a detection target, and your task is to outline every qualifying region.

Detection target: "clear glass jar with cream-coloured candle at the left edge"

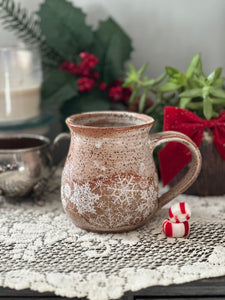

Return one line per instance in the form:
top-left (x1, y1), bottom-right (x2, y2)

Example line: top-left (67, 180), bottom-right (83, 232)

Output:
top-left (0, 48), bottom-right (42, 123)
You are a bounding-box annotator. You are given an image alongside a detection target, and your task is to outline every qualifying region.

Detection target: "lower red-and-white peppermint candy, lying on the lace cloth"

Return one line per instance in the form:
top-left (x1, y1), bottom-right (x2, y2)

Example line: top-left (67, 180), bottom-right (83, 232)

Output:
top-left (162, 219), bottom-right (189, 237)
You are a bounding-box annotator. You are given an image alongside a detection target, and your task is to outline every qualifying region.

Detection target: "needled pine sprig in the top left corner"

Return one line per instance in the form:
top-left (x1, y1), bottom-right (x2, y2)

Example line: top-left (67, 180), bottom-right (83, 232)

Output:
top-left (0, 0), bottom-right (61, 66)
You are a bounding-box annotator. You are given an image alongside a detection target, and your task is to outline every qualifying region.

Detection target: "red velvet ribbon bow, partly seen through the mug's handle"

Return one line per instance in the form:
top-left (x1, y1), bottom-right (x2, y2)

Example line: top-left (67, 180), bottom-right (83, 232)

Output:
top-left (158, 106), bottom-right (225, 185)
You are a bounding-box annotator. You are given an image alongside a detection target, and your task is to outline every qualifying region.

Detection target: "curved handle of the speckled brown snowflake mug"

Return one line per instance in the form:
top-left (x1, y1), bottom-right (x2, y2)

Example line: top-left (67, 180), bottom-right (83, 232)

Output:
top-left (150, 131), bottom-right (202, 209)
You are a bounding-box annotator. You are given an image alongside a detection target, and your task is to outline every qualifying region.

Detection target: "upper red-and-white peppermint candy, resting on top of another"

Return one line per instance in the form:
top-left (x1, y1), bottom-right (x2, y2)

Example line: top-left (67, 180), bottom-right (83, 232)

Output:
top-left (169, 202), bottom-right (191, 223)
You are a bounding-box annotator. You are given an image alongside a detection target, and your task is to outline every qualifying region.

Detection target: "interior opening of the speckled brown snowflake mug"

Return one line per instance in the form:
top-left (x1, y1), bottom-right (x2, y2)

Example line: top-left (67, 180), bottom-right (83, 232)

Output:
top-left (69, 112), bottom-right (154, 128)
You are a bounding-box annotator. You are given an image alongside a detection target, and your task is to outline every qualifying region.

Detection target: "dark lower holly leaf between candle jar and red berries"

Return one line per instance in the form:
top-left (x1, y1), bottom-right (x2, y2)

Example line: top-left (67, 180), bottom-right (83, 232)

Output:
top-left (42, 69), bottom-right (77, 105)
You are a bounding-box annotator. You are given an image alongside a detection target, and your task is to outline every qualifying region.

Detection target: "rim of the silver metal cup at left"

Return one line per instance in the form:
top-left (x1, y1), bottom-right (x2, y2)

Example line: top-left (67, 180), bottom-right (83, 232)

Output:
top-left (0, 133), bottom-right (50, 154)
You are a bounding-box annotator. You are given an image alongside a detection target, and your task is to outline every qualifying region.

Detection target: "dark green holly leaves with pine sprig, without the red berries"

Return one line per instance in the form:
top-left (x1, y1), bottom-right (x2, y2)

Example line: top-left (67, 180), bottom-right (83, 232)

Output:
top-left (0, 0), bottom-right (132, 112)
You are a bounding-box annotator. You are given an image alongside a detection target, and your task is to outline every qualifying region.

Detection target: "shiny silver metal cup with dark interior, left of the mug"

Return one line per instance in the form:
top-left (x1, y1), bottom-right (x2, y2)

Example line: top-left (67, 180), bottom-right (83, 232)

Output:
top-left (0, 133), bottom-right (67, 198)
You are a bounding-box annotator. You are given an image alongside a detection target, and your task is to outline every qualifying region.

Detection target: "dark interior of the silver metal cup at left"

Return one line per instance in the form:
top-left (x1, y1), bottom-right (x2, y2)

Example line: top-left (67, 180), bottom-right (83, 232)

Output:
top-left (0, 137), bottom-right (47, 150)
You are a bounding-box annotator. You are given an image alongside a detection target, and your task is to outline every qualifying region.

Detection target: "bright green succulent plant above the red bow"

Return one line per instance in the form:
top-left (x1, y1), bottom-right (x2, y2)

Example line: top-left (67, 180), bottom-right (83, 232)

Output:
top-left (125, 54), bottom-right (225, 120)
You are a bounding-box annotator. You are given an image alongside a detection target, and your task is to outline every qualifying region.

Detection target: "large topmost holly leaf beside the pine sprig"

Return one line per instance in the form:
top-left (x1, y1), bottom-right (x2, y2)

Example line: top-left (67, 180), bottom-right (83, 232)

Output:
top-left (37, 0), bottom-right (93, 60)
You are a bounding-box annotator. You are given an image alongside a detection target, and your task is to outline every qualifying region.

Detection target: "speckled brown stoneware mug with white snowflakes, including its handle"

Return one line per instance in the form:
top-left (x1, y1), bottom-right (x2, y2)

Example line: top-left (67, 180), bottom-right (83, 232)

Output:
top-left (61, 111), bottom-right (201, 232)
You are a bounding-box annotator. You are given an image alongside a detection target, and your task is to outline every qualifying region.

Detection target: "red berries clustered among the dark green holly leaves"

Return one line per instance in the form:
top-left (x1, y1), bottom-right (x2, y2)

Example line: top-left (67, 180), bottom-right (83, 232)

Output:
top-left (60, 52), bottom-right (131, 102)
